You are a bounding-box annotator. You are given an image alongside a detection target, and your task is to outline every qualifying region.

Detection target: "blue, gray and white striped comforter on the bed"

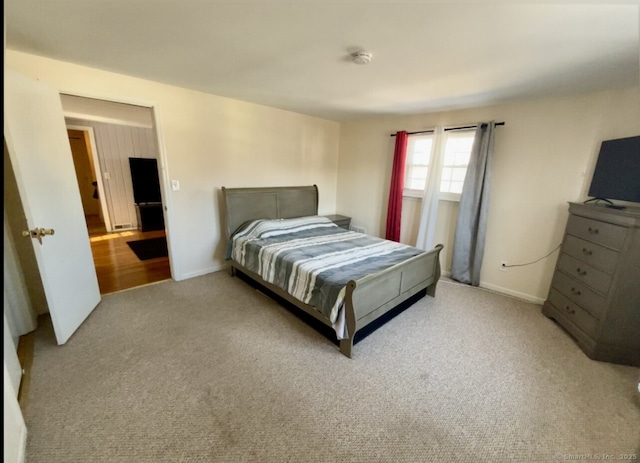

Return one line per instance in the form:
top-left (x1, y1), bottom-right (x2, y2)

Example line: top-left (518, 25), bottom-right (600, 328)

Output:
top-left (231, 216), bottom-right (424, 328)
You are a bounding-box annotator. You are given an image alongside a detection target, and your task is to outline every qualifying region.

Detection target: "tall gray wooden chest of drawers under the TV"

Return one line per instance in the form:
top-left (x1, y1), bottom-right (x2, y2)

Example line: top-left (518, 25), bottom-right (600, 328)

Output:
top-left (542, 203), bottom-right (640, 366)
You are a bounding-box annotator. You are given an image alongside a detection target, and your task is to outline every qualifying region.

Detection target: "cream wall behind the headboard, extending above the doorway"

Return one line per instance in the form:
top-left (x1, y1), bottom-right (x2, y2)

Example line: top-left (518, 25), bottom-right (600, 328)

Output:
top-left (5, 50), bottom-right (340, 280)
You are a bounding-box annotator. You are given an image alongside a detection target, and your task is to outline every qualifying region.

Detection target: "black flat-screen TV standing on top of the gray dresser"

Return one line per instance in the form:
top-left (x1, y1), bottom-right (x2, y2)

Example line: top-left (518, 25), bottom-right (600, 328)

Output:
top-left (589, 136), bottom-right (640, 202)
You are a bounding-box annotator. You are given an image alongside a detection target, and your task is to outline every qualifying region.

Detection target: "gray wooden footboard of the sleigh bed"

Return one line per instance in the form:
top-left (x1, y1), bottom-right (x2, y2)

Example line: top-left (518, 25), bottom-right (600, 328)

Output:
top-left (340, 244), bottom-right (443, 358)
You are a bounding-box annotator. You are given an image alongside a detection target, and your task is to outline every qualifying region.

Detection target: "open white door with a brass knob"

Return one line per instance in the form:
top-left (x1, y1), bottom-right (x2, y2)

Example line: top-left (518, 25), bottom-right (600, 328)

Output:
top-left (4, 68), bottom-right (100, 344)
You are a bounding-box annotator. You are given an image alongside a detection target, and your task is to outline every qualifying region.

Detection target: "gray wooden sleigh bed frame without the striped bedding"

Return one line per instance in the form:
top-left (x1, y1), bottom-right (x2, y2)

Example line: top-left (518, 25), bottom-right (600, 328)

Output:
top-left (222, 185), bottom-right (443, 358)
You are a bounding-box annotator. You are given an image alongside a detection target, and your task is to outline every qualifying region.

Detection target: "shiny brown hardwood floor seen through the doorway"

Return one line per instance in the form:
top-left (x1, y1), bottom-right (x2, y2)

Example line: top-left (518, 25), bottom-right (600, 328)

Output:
top-left (87, 216), bottom-right (171, 294)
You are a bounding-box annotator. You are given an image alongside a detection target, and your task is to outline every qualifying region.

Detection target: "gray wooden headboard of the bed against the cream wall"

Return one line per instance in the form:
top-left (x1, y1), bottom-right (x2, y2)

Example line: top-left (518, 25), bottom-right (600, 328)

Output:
top-left (222, 185), bottom-right (318, 239)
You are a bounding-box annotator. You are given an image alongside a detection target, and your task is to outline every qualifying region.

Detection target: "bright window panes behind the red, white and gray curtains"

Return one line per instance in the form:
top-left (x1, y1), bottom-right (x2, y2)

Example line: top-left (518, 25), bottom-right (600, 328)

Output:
top-left (404, 130), bottom-right (475, 201)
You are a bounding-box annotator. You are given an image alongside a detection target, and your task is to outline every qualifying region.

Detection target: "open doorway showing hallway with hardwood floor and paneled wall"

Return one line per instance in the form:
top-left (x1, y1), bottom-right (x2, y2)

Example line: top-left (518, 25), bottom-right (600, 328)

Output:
top-left (65, 101), bottom-right (171, 295)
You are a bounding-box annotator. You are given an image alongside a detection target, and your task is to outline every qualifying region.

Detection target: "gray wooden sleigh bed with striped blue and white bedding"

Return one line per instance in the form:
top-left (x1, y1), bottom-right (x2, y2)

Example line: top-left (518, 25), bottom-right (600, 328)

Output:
top-left (222, 185), bottom-right (442, 358)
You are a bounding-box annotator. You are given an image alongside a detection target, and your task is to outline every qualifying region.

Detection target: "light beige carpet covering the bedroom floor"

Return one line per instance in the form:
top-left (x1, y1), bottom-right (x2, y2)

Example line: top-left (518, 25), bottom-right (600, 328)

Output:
top-left (25, 272), bottom-right (640, 463)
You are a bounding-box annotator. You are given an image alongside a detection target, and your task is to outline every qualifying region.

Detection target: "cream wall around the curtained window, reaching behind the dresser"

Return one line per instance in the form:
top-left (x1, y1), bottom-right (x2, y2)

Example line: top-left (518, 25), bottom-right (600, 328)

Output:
top-left (337, 88), bottom-right (640, 302)
